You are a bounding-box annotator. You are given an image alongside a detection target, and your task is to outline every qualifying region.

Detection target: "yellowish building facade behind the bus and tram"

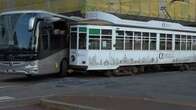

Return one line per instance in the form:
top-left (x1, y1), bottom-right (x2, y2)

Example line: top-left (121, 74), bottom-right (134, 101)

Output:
top-left (0, 0), bottom-right (196, 22)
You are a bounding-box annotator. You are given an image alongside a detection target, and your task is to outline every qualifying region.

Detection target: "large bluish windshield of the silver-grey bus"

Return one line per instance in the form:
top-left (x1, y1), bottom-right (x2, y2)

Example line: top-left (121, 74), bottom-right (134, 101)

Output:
top-left (0, 13), bottom-right (35, 51)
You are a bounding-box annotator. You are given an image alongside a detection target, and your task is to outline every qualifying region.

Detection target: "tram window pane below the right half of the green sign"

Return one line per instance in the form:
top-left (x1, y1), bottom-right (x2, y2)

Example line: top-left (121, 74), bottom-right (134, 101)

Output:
top-left (101, 36), bottom-right (112, 50)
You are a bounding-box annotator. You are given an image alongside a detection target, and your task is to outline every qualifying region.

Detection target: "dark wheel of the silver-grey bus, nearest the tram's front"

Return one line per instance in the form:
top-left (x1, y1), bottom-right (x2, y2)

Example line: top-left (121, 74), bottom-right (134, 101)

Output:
top-left (59, 60), bottom-right (68, 76)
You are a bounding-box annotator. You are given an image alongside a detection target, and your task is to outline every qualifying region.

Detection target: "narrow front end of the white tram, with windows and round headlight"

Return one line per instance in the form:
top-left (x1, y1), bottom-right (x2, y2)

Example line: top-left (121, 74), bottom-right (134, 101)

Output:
top-left (69, 26), bottom-right (87, 65)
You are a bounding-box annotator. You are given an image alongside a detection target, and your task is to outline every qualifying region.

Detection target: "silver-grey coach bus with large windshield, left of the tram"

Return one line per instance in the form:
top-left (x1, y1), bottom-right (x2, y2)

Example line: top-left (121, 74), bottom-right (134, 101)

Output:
top-left (0, 11), bottom-right (75, 76)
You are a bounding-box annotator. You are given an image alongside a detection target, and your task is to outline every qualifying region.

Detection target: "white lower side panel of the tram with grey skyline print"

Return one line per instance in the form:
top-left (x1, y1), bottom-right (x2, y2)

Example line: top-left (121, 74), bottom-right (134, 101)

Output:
top-left (88, 51), bottom-right (196, 70)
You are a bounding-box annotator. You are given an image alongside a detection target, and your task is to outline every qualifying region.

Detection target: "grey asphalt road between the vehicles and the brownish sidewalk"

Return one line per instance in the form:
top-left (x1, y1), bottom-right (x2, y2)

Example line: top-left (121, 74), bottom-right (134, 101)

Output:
top-left (0, 71), bottom-right (196, 109)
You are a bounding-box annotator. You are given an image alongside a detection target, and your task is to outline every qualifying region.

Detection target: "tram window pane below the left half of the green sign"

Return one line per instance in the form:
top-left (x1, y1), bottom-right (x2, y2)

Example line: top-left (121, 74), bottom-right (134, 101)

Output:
top-left (89, 35), bottom-right (100, 50)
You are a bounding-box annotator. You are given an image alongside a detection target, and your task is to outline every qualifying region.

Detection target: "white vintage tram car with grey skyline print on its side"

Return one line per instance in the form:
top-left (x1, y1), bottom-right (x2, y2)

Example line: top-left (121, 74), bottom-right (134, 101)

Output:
top-left (69, 12), bottom-right (196, 71)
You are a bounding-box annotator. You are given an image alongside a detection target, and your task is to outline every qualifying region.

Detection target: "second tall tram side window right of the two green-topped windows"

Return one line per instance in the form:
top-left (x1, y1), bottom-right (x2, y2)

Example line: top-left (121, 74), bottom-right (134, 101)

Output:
top-left (125, 31), bottom-right (133, 50)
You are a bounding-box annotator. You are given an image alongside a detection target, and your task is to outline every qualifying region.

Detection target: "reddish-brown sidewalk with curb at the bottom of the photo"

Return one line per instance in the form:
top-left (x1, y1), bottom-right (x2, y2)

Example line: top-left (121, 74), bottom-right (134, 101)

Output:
top-left (40, 96), bottom-right (196, 110)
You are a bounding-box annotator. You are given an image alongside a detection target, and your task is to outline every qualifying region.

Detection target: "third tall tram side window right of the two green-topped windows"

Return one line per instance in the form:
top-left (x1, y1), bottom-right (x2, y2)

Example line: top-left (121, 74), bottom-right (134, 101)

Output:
top-left (134, 32), bottom-right (141, 50)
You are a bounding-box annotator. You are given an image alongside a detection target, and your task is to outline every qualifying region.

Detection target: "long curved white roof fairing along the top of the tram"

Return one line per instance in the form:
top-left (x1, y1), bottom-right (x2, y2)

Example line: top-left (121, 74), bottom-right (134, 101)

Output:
top-left (86, 11), bottom-right (196, 32)
